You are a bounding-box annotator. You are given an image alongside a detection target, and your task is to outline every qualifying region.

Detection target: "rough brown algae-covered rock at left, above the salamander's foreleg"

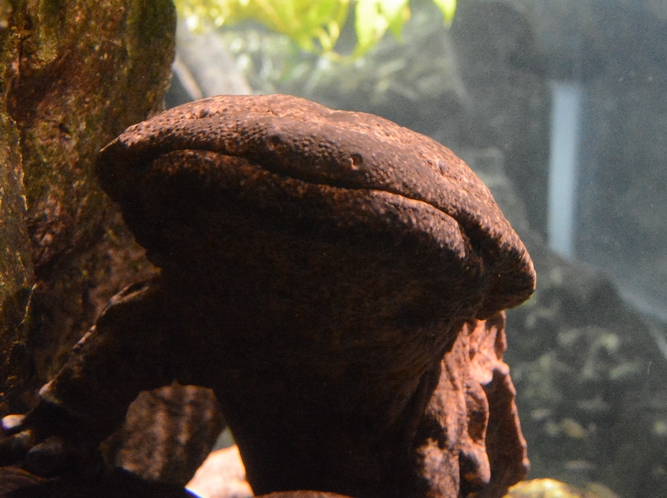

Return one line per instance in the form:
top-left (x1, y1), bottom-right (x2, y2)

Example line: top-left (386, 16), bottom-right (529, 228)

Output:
top-left (0, 0), bottom-right (176, 412)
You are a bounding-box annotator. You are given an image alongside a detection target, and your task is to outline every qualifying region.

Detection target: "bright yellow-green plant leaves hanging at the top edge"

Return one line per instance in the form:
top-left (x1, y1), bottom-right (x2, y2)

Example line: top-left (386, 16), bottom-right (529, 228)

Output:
top-left (175, 0), bottom-right (456, 56)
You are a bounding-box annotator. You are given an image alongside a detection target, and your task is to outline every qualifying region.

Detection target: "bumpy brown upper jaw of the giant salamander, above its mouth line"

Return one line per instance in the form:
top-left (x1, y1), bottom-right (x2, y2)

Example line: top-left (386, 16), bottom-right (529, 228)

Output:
top-left (98, 95), bottom-right (535, 315)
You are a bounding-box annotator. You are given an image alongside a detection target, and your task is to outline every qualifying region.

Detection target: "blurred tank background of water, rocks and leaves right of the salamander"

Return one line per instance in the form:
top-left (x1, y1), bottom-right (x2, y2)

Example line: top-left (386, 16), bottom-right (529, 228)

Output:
top-left (167, 0), bottom-right (667, 498)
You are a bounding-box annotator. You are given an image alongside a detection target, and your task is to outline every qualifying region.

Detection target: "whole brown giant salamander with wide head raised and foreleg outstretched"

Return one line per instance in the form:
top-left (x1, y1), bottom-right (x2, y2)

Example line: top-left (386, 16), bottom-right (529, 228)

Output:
top-left (0, 95), bottom-right (535, 497)
